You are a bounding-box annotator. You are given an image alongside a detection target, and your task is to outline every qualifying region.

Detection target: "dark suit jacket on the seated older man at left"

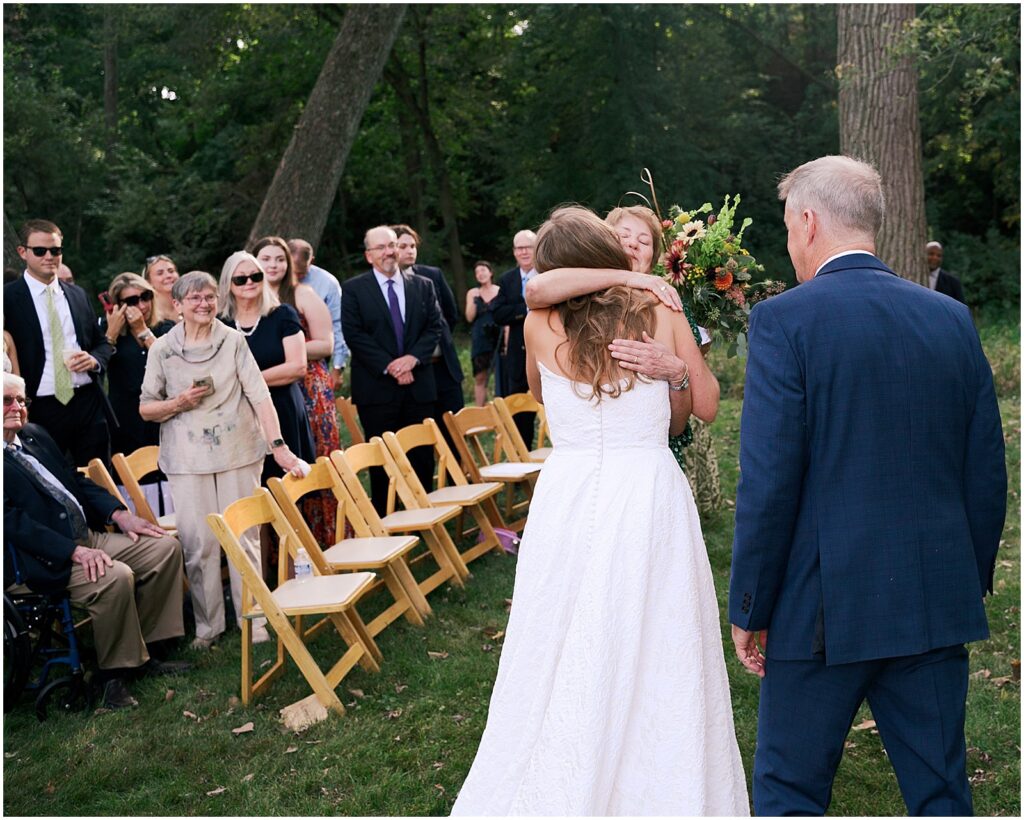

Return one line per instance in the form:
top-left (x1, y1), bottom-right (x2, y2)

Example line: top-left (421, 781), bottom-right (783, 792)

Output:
top-left (3, 424), bottom-right (124, 592)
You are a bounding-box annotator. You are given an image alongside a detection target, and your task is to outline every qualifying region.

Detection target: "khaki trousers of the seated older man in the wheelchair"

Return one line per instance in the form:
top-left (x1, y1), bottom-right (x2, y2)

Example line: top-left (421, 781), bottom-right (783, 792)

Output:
top-left (68, 532), bottom-right (185, 670)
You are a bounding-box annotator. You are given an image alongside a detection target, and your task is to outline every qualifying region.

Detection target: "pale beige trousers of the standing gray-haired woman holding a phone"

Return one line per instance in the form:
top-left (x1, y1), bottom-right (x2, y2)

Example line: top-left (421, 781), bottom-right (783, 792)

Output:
top-left (167, 459), bottom-right (263, 640)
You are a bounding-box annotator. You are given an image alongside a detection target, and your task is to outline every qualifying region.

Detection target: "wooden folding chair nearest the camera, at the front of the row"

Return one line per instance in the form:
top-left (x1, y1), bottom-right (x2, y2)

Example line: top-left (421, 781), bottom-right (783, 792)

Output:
top-left (206, 487), bottom-right (381, 715)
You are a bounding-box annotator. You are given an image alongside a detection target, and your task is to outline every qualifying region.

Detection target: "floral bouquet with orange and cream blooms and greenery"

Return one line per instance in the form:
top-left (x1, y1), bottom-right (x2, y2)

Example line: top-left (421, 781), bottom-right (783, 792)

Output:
top-left (654, 193), bottom-right (785, 356)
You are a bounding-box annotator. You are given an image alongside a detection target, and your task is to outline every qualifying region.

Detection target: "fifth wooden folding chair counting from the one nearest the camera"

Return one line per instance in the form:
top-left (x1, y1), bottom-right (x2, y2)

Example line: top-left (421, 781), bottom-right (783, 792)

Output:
top-left (444, 403), bottom-right (542, 532)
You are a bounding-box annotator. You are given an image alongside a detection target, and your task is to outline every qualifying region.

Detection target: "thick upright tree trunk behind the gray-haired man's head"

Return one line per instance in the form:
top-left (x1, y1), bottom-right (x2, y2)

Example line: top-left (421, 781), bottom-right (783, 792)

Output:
top-left (837, 3), bottom-right (928, 285)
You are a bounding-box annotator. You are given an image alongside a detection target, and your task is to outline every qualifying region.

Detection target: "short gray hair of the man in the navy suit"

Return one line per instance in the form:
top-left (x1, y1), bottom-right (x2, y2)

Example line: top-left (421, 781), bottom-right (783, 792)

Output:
top-left (778, 156), bottom-right (886, 238)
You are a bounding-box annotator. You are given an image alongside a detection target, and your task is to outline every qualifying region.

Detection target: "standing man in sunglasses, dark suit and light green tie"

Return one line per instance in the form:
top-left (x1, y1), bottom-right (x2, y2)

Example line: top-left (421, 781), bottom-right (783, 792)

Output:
top-left (3, 219), bottom-right (114, 467)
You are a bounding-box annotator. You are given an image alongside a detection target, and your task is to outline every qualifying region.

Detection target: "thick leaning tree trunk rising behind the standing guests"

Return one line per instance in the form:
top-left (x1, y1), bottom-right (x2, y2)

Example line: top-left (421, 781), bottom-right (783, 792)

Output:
top-left (249, 4), bottom-right (406, 248)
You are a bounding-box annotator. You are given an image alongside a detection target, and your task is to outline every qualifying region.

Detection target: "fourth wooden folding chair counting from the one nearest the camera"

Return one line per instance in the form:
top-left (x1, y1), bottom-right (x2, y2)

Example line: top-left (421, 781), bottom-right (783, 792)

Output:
top-left (383, 419), bottom-right (505, 564)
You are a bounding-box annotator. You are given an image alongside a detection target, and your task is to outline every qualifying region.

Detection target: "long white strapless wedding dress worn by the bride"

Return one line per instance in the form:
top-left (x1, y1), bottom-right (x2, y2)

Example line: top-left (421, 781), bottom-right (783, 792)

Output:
top-left (452, 364), bottom-right (750, 816)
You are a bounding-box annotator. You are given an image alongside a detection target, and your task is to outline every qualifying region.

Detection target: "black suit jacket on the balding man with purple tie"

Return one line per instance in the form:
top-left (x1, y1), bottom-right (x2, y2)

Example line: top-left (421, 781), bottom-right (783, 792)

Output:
top-left (341, 270), bottom-right (443, 404)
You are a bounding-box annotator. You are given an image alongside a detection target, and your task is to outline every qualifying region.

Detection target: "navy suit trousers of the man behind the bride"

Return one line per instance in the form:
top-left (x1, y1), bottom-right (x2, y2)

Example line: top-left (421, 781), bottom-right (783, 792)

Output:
top-left (754, 645), bottom-right (973, 817)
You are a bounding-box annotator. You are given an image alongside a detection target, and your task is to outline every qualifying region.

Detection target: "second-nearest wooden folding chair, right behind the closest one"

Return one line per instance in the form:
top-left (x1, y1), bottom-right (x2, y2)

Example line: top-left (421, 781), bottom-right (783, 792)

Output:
top-left (266, 456), bottom-right (430, 637)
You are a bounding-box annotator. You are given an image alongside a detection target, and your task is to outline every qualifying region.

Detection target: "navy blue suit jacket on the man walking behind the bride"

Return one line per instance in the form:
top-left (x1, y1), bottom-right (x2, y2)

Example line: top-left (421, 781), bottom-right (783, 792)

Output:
top-left (729, 254), bottom-right (1007, 664)
